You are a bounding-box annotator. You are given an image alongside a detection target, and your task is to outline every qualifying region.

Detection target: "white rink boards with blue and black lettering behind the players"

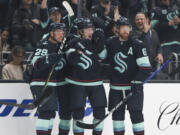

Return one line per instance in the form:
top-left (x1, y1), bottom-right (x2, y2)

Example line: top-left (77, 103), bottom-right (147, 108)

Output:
top-left (0, 83), bottom-right (180, 135)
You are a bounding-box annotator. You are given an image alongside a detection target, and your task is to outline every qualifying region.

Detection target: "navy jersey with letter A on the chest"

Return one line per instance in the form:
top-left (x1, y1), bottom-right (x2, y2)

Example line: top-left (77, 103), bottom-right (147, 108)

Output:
top-left (106, 37), bottom-right (151, 90)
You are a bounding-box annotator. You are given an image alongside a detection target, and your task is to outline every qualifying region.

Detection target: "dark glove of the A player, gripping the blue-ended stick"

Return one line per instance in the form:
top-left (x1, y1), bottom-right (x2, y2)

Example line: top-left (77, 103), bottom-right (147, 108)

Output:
top-left (131, 80), bottom-right (143, 95)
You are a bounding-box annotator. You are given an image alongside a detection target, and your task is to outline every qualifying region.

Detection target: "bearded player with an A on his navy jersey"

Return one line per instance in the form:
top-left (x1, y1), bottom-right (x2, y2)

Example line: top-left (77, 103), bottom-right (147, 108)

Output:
top-left (106, 17), bottom-right (151, 135)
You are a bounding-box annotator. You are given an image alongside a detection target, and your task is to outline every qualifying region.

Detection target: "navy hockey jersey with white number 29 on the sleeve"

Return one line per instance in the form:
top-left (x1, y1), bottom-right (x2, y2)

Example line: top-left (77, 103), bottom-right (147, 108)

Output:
top-left (30, 39), bottom-right (67, 86)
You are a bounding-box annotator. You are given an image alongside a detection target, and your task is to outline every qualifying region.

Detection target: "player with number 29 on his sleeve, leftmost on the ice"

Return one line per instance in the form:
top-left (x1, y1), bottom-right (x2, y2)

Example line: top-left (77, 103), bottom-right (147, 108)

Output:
top-left (30, 23), bottom-right (67, 135)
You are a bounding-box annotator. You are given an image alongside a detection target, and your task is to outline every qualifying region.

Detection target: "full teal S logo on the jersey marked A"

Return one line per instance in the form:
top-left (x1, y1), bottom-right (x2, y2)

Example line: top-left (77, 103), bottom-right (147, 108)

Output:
top-left (114, 52), bottom-right (127, 73)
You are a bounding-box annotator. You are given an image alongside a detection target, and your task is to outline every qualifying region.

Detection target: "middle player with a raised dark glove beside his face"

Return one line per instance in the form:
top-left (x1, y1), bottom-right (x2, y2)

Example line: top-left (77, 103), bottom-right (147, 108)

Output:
top-left (65, 18), bottom-right (107, 135)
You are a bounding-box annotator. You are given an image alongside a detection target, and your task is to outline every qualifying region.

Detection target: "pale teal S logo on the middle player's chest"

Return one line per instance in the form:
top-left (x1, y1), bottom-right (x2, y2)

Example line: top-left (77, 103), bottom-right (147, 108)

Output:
top-left (78, 54), bottom-right (92, 70)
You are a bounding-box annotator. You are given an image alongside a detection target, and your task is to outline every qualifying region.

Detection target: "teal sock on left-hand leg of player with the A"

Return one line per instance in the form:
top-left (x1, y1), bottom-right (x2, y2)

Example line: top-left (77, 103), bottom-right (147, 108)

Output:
top-left (113, 120), bottom-right (125, 135)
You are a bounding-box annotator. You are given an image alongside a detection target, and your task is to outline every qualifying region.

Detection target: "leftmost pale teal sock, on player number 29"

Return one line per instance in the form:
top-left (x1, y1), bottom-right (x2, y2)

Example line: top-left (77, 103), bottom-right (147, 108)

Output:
top-left (36, 119), bottom-right (51, 135)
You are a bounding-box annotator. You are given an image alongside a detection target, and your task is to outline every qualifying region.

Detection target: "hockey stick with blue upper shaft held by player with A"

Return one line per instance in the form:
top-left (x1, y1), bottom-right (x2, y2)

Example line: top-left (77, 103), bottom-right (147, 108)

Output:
top-left (76, 60), bottom-right (171, 129)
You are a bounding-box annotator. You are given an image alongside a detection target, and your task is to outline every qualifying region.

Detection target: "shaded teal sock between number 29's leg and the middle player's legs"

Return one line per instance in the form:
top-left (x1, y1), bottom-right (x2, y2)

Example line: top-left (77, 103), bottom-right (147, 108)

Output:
top-left (59, 119), bottom-right (71, 135)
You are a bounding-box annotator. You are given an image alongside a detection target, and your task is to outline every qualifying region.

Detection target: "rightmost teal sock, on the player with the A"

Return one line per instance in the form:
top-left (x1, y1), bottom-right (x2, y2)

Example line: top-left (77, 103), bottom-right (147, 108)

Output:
top-left (133, 122), bottom-right (144, 135)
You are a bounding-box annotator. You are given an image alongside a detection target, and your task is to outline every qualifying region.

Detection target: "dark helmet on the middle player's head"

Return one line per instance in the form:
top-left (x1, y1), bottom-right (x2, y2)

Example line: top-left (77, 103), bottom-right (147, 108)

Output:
top-left (77, 18), bottom-right (94, 30)
